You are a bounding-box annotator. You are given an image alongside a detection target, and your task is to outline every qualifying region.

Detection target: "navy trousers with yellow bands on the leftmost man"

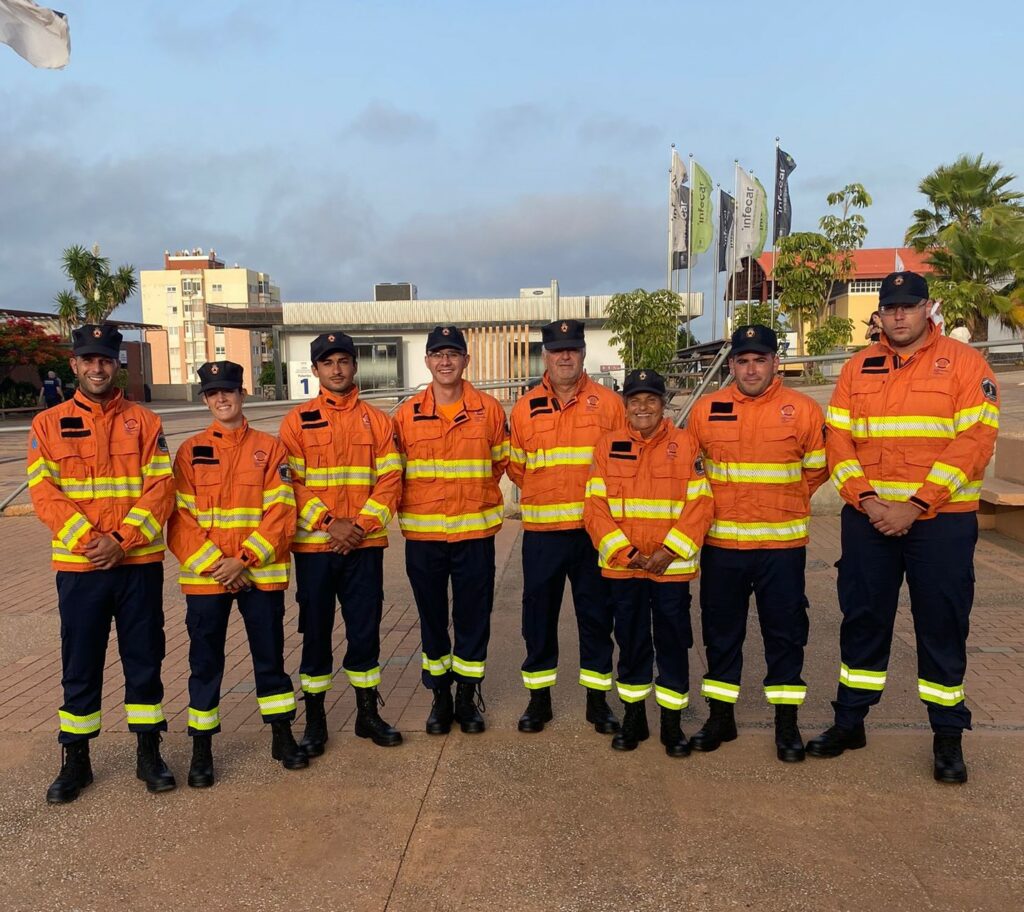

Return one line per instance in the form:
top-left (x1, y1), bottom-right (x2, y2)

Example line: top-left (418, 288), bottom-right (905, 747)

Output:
top-left (56, 562), bottom-right (167, 744)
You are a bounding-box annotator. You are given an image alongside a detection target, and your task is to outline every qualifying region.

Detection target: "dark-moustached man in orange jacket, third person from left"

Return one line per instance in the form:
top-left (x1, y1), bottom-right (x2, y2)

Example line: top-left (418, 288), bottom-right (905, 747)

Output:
top-left (281, 330), bottom-right (401, 756)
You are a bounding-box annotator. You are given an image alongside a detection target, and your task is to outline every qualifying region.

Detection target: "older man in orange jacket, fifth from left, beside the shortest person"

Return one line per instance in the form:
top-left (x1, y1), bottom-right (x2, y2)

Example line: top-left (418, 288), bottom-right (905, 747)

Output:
top-left (508, 319), bottom-right (626, 734)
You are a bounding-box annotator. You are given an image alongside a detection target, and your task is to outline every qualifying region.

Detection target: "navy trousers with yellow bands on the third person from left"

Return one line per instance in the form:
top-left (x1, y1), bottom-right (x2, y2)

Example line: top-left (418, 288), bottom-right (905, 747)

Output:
top-left (294, 548), bottom-right (384, 693)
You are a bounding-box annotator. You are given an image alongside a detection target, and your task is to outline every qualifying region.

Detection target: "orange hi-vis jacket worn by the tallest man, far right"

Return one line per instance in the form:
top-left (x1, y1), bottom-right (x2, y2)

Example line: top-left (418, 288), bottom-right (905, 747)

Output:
top-left (826, 327), bottom-right (999, 519)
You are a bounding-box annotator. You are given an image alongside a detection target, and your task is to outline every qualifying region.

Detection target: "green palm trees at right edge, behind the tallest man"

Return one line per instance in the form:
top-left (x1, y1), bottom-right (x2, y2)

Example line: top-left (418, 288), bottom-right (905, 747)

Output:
top-left (906, 155), bottom-right (1024, 341)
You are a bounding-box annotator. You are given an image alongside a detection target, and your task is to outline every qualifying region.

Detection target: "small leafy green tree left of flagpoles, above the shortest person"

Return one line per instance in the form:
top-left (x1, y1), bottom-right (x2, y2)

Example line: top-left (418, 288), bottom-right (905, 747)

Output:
top-left (605, 289), bottom-right (683, 372)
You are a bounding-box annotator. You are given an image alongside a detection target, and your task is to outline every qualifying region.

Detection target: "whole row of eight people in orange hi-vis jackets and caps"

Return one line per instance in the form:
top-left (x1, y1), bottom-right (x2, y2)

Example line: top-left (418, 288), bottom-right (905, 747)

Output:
top-left (28, 272), bottom-right (998, 804)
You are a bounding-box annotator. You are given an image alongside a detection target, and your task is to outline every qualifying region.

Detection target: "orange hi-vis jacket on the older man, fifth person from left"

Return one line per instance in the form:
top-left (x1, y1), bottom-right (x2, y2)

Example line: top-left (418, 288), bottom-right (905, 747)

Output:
top-left (507, 374), bottom-right (626, 532)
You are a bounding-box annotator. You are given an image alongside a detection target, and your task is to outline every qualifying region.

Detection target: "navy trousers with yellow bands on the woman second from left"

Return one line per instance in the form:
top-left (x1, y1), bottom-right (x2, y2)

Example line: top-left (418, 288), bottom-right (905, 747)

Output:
top-left (185, 589), bottom-right (295, 735)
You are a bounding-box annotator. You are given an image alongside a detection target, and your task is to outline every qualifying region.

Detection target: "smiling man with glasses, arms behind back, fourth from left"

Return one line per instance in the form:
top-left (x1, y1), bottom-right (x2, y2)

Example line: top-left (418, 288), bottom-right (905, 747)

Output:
top-left (394, 327), bottom-right (509, 735)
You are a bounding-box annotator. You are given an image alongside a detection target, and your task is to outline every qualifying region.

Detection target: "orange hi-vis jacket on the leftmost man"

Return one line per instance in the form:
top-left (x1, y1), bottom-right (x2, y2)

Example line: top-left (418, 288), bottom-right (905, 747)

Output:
top-left (29, 391), bottom-right (174, 572)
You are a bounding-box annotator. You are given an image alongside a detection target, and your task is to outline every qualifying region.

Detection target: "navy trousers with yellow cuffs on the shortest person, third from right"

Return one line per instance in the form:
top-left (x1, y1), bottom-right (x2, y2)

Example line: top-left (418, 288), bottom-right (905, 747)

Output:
top-left (608, 578), bottom-right (693, 709)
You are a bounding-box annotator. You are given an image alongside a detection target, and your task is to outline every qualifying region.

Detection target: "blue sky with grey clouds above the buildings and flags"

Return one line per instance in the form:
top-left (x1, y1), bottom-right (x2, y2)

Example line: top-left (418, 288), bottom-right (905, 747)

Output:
top-left (0, 0), bottom-right (1024, 338)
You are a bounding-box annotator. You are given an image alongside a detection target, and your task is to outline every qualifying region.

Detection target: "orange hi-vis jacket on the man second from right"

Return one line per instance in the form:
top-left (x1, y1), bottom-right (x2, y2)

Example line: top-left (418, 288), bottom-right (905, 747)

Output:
top-left (687, 377), bottom-right (828, 550)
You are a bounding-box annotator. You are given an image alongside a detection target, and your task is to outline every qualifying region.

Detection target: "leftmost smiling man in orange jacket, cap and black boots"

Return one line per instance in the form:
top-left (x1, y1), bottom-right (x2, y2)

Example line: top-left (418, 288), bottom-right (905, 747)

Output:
top-left (29, 323), bottom-right (175, 804)
